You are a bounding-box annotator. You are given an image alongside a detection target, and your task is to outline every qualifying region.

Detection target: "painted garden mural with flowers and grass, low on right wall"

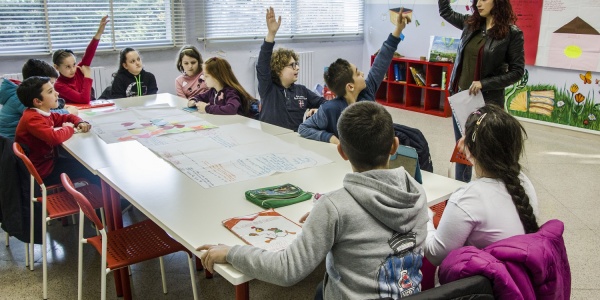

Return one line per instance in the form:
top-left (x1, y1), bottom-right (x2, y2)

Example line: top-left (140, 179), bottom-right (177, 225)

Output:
top-left (505, 70), bottom-right (600, 131)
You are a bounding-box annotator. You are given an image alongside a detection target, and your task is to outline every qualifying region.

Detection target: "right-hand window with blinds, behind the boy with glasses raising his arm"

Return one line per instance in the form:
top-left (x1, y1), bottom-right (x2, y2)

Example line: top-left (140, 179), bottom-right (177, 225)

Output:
top-left (196, 0), bottom-right (364, 42)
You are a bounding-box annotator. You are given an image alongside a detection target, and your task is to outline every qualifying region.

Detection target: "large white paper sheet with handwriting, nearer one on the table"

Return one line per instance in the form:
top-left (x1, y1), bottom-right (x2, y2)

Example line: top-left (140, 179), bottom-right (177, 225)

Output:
top-left (138, 124), bottom-right (331, 188)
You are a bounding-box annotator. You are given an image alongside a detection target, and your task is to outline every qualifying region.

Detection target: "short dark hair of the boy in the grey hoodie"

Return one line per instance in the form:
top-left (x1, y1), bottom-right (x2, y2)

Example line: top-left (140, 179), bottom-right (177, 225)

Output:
top-left (337, 101), bottom-right (395, 172)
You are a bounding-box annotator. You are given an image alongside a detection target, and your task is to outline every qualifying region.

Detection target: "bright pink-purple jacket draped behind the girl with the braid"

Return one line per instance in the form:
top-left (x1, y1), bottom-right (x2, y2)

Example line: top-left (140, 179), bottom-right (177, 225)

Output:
top-left (439, 220), bottom-right (571, 300)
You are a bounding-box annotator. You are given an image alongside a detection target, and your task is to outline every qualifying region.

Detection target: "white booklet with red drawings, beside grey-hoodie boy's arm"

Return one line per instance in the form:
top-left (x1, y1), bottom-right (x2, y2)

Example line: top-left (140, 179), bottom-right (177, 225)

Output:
top-left (223, 209), bottom-right (302, 251)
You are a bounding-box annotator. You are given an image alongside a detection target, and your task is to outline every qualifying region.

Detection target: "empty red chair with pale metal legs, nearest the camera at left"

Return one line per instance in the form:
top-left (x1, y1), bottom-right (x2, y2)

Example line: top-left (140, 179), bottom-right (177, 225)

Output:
top-left (60, 173), bottom-right (198, 300)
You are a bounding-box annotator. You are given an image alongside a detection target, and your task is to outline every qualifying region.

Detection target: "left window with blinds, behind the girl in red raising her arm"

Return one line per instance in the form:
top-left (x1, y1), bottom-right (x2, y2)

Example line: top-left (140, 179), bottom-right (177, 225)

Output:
top-left (0, 0), bottom-right (185, 55)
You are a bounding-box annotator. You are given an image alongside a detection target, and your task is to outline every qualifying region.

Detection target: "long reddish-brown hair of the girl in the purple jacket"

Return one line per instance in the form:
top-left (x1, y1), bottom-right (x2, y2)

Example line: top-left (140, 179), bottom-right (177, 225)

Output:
top-left (204, 57), bottom-right (254, 114)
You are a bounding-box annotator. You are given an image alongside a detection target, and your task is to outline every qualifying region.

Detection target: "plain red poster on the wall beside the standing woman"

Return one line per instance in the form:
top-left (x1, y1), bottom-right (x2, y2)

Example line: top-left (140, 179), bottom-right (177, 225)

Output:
top-left (510, 0), bottom-right (543, 65)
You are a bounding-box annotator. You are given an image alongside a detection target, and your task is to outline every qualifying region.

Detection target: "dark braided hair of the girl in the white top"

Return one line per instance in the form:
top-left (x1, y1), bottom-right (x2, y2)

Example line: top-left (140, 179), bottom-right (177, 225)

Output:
top-left (465, 104), bottom-right (539, 233)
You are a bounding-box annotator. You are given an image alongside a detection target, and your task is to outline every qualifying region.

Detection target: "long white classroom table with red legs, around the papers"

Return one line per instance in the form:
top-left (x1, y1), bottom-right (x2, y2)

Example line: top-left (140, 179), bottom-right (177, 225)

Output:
top-left (63, 94), bottom-right (464, 299)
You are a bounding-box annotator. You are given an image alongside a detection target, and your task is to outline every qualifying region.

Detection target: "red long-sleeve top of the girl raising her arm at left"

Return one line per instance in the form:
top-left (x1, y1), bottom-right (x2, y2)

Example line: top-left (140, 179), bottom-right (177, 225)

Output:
top-left (54, 38), bottom-right (100, 104)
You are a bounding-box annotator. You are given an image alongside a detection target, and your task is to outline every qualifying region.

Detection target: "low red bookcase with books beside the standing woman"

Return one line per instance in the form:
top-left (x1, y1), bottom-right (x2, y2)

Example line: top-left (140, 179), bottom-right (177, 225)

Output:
top-left (371, 56), bottom-right (452, 117)
